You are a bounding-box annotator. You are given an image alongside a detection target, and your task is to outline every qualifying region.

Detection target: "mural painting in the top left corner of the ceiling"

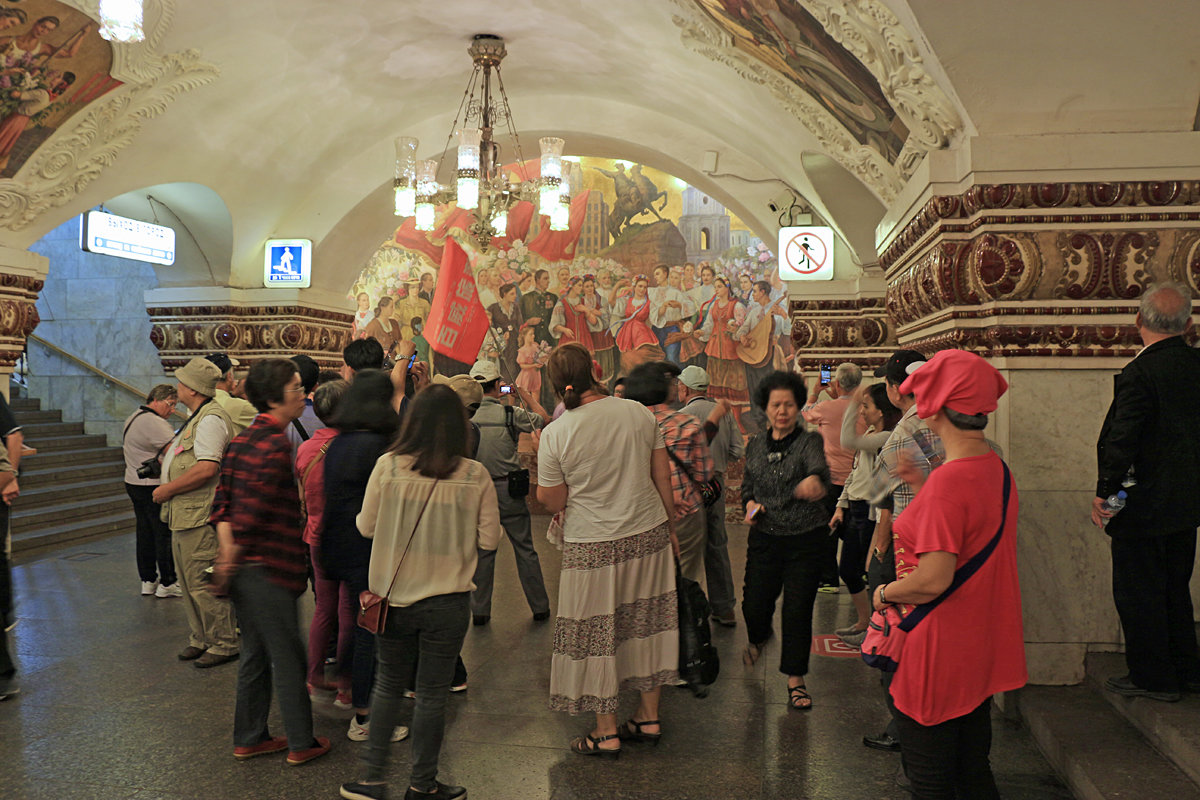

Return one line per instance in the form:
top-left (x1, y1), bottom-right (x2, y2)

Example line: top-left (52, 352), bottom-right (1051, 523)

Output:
top-left (0, 0), bottom-right (121, 178)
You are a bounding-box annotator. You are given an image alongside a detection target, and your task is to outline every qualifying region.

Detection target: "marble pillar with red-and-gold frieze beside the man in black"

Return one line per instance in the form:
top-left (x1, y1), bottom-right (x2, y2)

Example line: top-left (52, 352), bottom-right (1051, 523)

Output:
top-left (880, 180), bottom-right (1200, 684)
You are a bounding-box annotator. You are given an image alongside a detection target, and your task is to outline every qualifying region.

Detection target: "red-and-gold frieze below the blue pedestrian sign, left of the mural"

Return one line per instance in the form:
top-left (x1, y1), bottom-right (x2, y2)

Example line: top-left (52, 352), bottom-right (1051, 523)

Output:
top-left (146, 306), bottom-right (354, 371)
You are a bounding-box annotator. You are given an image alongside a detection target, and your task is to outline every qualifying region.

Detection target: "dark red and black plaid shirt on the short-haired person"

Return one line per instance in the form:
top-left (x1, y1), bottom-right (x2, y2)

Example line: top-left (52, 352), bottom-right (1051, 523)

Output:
top-left (210, 414), bottom-right (308, 596)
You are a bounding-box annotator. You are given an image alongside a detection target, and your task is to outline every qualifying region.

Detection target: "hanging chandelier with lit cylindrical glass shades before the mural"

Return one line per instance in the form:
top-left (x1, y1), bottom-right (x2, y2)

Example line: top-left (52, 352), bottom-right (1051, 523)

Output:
top-left (394, 34), bottom-right (571, 251)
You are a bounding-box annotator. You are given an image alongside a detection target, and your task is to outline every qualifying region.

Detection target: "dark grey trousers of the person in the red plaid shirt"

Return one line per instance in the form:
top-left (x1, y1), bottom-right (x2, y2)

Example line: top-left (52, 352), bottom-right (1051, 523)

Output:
top-left (229, 566), bottom-right (316, 752)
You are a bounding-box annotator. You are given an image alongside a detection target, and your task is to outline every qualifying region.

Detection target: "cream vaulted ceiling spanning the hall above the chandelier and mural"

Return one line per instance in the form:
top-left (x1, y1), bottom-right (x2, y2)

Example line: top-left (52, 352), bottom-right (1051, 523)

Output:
top-left (0, 0), bottom-right (1200, 298)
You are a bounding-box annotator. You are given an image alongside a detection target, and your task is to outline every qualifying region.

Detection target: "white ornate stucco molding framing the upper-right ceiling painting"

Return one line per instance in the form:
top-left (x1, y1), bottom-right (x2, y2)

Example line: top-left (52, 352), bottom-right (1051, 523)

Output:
top-left (672, 0), bottom-right (962, 204)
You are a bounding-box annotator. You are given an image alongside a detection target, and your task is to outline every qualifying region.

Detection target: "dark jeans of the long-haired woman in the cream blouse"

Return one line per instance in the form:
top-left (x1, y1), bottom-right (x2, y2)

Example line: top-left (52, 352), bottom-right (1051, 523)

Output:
top-left (364, 593), bottom-right (470, 792)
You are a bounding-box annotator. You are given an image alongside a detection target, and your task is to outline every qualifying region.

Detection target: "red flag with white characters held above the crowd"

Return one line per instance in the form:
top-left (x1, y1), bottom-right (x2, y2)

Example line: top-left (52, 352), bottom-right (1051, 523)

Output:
top-left (425, 239), bottom-right (488, 363)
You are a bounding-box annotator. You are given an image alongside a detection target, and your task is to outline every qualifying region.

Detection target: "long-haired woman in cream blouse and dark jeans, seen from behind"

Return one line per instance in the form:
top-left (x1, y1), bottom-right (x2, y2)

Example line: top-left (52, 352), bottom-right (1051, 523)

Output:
top-left (342, 385), bottom-right (500, 800)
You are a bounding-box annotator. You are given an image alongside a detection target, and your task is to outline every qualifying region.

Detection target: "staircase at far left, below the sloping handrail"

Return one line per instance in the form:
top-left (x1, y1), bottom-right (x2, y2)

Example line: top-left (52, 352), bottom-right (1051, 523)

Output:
top-left (8, 397), bottom-right (134, 557)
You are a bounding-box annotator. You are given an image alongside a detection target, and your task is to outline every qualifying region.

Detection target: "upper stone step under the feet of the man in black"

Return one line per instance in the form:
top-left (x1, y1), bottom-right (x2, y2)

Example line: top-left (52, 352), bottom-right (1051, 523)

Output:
top-left (1087, 652), bottom-right (1200, 786)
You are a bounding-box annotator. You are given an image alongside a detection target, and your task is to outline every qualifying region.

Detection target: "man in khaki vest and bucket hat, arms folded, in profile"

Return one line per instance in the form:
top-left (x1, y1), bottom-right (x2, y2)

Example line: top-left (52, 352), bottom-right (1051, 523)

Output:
top-left (152, 359), bottom-right (238, 669)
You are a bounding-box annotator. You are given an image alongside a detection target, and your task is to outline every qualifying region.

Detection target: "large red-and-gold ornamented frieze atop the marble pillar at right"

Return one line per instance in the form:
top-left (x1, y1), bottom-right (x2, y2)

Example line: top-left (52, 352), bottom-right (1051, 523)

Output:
top-left (881, 181), bottom-right (1200, 356)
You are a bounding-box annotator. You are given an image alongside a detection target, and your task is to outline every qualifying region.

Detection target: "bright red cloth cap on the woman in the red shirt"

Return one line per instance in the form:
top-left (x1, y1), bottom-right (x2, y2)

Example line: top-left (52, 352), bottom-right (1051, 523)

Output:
top-left (900, 350), bottom-right (1008, 419)
